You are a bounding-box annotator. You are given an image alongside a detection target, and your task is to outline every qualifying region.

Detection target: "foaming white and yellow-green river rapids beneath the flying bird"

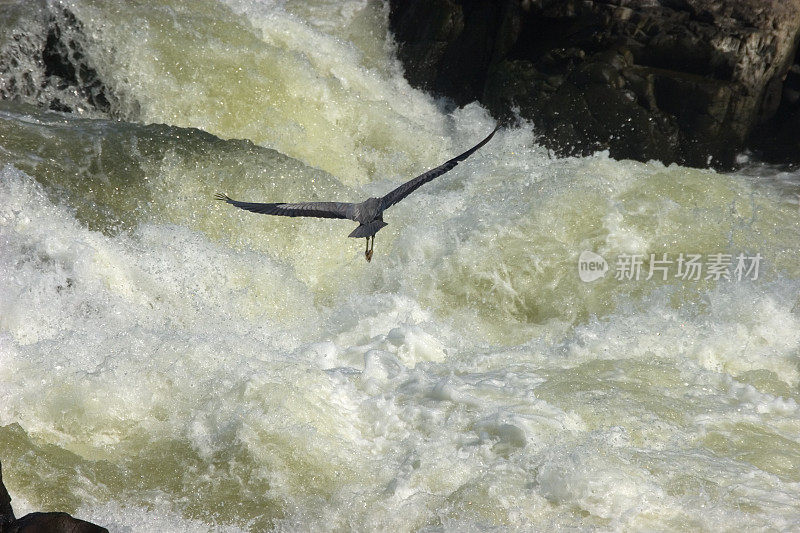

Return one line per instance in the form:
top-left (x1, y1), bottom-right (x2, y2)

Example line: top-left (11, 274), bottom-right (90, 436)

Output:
top-left (0, 0), bottom-right (800, 532)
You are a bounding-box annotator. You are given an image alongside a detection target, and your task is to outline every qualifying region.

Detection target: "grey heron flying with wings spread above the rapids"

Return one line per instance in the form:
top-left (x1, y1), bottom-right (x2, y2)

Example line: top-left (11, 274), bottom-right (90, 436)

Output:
top-left (216, 126), bottom-right (499, 261)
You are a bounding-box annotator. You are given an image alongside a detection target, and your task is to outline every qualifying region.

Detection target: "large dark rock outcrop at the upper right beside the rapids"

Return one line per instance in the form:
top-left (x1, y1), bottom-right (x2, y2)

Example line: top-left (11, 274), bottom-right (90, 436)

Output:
top-left (390, 0), bottom-right (800, 167)
